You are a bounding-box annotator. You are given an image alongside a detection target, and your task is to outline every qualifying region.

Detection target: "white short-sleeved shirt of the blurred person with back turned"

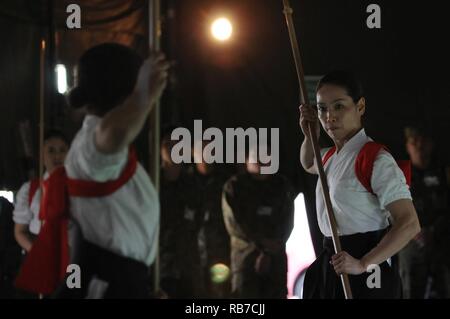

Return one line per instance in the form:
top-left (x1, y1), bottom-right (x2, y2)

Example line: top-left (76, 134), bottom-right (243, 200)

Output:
top-left (65, 115), bottom-right (159, 265)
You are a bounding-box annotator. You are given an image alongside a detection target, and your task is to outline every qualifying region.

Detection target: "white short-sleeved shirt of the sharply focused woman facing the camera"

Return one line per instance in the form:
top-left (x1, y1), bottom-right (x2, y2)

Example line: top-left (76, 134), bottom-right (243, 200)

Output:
top-left (316, 129), bottom-right (411, 237)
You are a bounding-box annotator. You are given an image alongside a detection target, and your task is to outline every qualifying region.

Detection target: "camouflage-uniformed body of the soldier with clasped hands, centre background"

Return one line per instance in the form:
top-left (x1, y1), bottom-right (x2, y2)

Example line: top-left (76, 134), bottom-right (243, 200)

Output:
top-left (222, 149), bottom-right (294, 298)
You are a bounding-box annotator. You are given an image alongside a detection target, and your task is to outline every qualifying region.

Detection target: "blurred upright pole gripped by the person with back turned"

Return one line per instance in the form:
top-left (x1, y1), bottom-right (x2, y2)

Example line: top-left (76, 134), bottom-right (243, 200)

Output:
top-left (148, 0), bottom-right (161, 294)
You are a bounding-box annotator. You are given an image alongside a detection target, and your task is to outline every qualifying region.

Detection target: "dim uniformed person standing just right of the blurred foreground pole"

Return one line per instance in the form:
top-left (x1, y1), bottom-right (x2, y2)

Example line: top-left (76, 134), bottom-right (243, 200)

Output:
top-left (160, 135), bottom-right (206, 298)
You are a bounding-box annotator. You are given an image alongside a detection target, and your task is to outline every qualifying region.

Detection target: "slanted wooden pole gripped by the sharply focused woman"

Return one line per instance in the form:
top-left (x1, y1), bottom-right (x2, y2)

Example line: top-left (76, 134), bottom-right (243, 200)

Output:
top-left (283, 0), bottom-right (353, 299)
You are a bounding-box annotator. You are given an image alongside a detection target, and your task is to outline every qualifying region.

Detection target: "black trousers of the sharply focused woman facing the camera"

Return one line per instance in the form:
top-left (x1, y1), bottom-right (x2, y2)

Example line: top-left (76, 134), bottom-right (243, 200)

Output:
top-left (303, 229), bottom-right (402, 299)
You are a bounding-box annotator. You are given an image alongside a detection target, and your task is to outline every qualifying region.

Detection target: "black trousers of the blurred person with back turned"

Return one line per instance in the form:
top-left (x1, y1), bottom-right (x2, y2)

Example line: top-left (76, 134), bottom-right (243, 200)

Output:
top-left (52, 240), bottom-right (151, 299)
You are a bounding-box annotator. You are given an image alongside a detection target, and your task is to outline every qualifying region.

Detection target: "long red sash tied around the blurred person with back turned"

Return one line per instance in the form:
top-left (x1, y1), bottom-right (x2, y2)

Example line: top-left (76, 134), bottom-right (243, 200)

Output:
top-left (15, 148), bottom-right (137, 295)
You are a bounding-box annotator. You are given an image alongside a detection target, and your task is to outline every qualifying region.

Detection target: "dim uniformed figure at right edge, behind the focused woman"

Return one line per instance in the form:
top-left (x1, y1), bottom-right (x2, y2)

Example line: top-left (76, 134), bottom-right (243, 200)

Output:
top-left (399, 126), bottom-right (450, 299)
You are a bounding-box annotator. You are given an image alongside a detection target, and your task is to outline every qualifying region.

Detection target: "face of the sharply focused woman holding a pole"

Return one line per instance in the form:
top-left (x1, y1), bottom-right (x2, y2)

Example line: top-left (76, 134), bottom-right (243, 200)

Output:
top-left (317, 84), bottom-right (365, 141)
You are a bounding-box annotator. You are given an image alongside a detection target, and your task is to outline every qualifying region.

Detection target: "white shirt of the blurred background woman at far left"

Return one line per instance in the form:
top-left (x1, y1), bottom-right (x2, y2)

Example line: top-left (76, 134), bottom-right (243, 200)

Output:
top-left (13, 173), bottom-right (48, 235)
